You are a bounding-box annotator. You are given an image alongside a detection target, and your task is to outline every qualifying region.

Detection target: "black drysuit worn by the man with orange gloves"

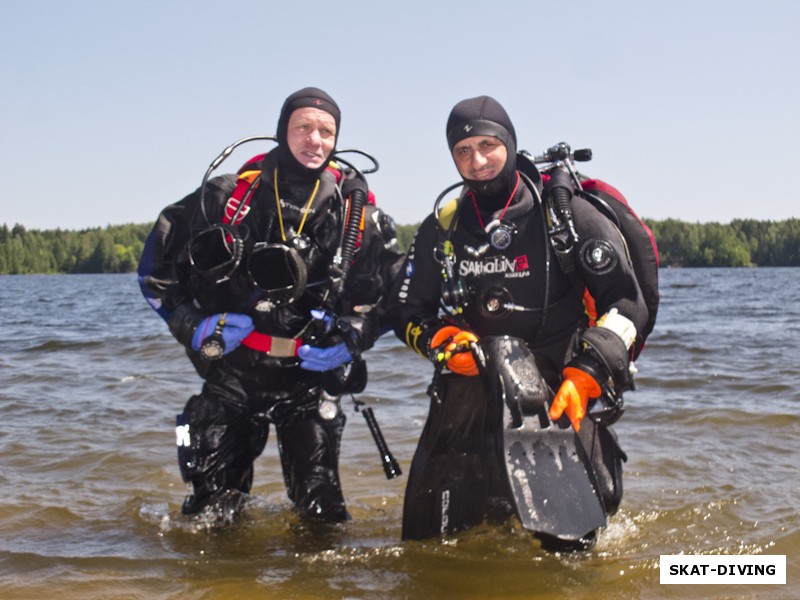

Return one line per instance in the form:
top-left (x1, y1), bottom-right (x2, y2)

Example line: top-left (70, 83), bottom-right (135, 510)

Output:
top-left (391, 172), bottom-right (648, 524)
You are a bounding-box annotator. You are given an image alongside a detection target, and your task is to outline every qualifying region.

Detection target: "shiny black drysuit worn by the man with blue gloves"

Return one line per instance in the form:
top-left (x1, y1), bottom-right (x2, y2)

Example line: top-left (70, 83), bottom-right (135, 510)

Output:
top-left (139, 150), bottom-right (403, 521)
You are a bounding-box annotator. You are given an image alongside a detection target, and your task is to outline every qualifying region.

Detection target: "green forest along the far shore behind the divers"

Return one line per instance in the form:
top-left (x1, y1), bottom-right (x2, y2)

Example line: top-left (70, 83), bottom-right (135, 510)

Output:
top-left (0, 219), bottom-right (800, 275)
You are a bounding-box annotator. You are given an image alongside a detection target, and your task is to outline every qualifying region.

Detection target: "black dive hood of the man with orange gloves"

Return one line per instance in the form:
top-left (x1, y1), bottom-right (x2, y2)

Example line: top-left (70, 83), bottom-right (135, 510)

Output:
top-left (447, 96), bottom-right (517, 201)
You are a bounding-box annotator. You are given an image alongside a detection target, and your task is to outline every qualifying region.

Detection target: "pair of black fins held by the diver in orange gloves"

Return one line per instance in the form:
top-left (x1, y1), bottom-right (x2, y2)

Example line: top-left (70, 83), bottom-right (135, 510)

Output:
top-left (402, 336), bottom-right (606, 546)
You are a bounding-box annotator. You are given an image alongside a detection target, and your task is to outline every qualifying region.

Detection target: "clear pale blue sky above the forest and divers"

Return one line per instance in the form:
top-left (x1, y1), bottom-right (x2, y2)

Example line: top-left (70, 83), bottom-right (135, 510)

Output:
top-left (0, 0), bottom-right (800, 229)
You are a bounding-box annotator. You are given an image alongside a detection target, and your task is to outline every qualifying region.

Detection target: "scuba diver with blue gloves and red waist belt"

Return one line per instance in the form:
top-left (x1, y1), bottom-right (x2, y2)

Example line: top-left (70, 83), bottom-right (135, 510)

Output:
top-left (138, 87), bottom-right (404, 523)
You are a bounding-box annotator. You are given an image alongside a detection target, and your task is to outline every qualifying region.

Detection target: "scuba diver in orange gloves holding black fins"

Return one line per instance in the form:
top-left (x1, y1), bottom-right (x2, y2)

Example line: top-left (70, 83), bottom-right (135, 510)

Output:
top-left (390, 96), bottom-right (655, 550)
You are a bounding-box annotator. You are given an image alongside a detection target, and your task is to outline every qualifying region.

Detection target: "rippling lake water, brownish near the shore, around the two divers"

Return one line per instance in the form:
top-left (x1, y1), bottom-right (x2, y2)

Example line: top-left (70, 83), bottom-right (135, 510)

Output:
top-left (0, 269), bottom-right (800, 600)
